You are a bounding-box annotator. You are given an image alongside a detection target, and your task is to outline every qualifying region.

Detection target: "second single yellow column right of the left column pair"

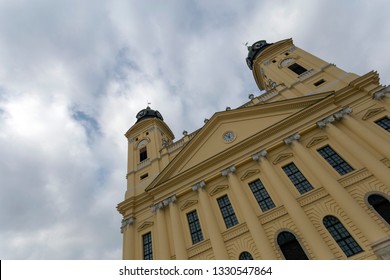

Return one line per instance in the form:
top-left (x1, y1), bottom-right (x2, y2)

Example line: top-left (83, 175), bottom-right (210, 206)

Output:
top-left (222, 166), bottom-right (276, 260)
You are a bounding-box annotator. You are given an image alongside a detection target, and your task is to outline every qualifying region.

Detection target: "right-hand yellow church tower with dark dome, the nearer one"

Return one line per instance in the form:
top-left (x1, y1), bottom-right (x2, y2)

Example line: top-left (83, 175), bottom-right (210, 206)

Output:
top-left (246, 39), bottom-right (358, 101)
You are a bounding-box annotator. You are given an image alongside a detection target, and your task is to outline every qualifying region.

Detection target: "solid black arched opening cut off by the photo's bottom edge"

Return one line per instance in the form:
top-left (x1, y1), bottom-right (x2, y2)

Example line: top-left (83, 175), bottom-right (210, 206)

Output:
top-left (277, 231), bottom-right (308, 260)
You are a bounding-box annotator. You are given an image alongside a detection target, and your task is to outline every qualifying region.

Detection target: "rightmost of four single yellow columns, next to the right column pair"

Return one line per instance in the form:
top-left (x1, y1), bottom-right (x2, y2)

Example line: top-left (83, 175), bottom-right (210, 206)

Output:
top-left (285, 134), bottom-right (388, 243)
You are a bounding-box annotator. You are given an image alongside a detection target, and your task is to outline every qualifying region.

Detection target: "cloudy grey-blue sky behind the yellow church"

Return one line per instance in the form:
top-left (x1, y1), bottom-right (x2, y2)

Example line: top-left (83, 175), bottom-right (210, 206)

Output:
top-left (0, 0), bottom-right (390, 259)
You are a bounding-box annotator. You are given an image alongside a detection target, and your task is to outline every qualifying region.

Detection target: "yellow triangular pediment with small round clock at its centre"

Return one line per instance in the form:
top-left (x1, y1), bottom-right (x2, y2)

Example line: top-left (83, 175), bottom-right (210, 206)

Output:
top-left (146, 92), bottom-right (332, 191)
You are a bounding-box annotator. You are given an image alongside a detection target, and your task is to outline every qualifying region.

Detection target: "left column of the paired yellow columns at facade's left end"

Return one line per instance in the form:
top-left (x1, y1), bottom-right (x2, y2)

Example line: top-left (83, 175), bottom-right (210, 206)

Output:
top-left (151, 202), bottom-right (171, 260)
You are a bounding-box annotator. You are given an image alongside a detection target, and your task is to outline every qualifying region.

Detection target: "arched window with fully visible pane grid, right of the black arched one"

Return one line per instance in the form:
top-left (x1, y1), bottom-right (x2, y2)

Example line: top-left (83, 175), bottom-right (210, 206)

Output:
top-left (323, 216), bottom-right (363, 257)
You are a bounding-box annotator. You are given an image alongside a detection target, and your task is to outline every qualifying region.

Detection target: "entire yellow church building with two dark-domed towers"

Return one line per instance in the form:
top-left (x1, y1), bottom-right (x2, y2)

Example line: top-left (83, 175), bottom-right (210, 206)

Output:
top-left (117, 39), bottom-right (390, 260)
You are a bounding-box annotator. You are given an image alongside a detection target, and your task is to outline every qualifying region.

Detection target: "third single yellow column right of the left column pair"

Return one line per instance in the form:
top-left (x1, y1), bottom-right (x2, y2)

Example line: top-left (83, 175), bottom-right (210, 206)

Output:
top-left (252, 151), bottom-right (335, 260)
